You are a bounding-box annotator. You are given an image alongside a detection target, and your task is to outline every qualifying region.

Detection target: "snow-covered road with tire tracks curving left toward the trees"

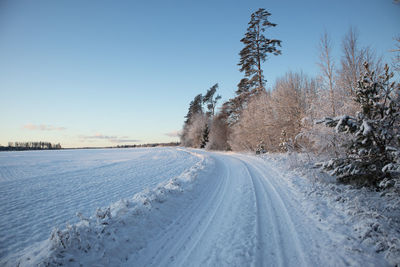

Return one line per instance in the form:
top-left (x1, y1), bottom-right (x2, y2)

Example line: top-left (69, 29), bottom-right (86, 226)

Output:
top-left (127, 154), bottom-right (308, 266)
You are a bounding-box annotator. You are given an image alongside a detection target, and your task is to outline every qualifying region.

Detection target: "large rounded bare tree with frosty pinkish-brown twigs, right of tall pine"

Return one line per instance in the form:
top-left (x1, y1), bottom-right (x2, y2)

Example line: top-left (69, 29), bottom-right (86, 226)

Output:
top-left (229, 72), bottom-right (317, 151)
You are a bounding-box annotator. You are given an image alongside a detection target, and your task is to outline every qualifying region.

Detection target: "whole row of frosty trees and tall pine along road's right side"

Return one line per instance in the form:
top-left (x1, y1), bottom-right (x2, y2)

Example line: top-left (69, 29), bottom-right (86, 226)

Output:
top-left (181, 8), bottom-right (400, 187)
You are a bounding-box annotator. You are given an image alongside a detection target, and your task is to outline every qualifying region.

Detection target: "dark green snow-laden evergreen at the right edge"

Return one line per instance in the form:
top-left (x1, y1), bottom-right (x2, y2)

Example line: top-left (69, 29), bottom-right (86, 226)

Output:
top-left (320, 63), bottom-right (400, 187)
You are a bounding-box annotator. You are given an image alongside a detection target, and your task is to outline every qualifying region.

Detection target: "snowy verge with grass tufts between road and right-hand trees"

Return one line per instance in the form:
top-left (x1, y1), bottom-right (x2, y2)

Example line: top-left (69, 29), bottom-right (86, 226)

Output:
top-left (261, 154), bottom-right (400, 266)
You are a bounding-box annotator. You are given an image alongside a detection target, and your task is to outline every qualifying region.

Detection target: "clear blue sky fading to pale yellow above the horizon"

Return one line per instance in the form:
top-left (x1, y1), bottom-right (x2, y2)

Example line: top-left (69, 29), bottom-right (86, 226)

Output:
top-left (0, 0), bottom-right (400, 147)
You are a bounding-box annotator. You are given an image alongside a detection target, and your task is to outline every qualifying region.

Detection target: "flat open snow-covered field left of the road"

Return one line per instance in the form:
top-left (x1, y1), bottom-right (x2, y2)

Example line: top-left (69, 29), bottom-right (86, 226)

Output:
top-left (0, 148), bottom-right (199, 264)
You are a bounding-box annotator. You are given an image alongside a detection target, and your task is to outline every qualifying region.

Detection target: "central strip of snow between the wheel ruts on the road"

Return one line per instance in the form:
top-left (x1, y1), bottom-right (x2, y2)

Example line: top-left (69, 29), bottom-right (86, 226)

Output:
top-left (182, 154), bottom-right (256, 266)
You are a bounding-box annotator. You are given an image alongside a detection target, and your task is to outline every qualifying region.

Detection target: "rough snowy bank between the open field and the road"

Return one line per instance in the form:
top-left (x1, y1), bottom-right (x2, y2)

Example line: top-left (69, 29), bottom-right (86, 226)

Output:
top-left (4, 151), bottom-right (213, 266)
